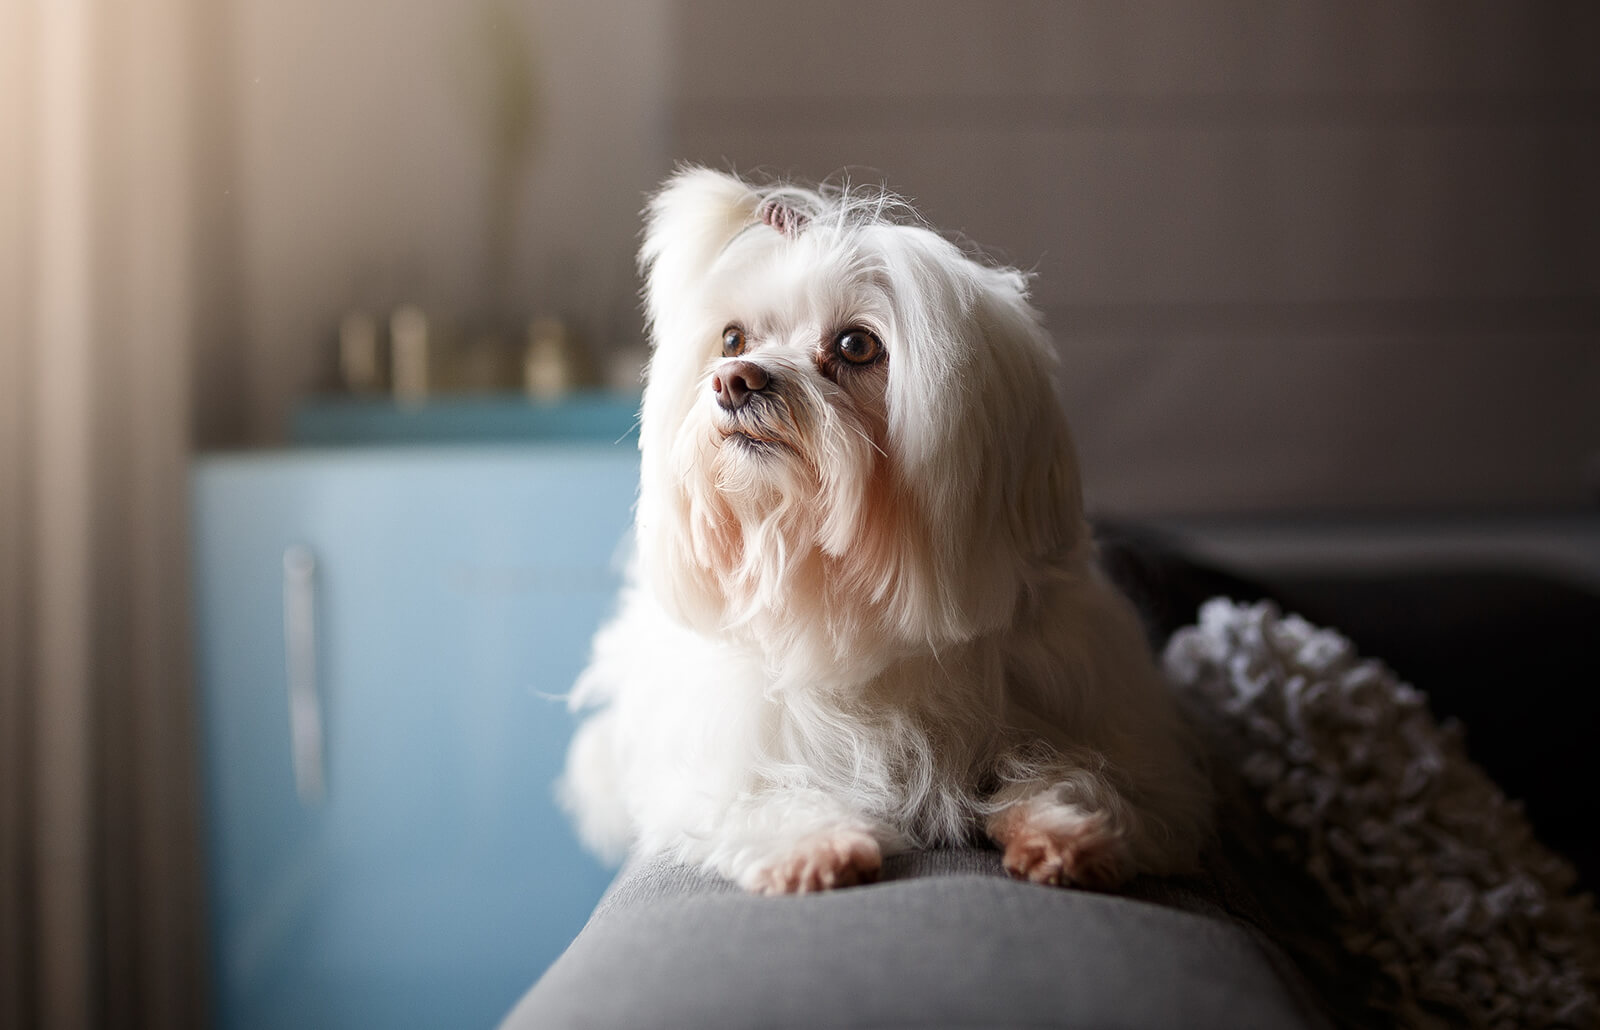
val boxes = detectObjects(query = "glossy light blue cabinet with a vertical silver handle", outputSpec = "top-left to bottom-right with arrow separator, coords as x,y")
192,441 -> 638,1030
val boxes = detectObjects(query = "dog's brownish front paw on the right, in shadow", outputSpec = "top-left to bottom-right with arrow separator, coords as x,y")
989,801 -> 1133,891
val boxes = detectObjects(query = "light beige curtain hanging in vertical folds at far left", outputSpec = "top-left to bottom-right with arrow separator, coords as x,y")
0,0 -> 205,1030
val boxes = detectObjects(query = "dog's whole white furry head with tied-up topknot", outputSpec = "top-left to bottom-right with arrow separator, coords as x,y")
624,170 -> 1085,675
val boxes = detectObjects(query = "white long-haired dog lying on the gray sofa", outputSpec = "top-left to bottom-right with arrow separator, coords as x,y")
562,168 -> 1208,892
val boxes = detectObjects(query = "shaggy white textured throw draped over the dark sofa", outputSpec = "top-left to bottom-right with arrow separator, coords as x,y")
1165,600 -> 1600,1028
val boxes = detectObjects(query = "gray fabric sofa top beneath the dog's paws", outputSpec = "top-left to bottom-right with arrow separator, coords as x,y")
506,848 -> 1325,1030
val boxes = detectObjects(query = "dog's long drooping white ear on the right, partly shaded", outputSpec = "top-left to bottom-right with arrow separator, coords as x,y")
888,227 -> 1083,640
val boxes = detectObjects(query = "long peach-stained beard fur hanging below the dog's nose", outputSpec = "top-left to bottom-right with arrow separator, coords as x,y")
670,350 -> 893,678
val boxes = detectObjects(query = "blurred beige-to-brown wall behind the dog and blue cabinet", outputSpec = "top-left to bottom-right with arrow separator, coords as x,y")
200,0 -> 1600,512
